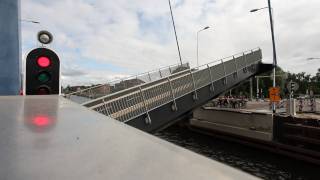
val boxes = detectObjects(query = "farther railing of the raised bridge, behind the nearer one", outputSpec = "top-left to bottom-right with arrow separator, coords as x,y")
64,63 -> 190,103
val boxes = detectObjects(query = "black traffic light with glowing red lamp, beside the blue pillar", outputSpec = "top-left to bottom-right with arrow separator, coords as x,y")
26,47 -> 60,95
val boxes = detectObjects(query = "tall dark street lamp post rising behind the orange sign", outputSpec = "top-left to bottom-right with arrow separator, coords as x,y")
250,0 -> 277,113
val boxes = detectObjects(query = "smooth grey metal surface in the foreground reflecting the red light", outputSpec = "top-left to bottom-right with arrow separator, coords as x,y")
0,96 -> 256,180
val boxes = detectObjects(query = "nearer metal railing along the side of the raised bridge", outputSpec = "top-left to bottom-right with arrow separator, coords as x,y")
83,49 -> 262,123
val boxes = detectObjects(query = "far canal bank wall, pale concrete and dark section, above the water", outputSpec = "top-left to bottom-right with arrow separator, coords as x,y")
188,102 -> 320,165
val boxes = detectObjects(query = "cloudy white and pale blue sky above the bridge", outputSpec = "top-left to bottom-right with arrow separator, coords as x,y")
21,0 -> 320,85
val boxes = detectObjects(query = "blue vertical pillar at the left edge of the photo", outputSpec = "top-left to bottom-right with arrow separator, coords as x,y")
0,0 -> 21,95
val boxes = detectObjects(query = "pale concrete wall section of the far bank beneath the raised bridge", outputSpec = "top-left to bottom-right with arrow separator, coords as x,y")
190,107 -> 273,141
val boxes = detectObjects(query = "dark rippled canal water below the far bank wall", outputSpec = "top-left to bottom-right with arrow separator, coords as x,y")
155,126 -> 320,180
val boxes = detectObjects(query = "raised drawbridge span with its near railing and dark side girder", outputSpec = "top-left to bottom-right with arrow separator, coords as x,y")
83,49 -> 272,132
